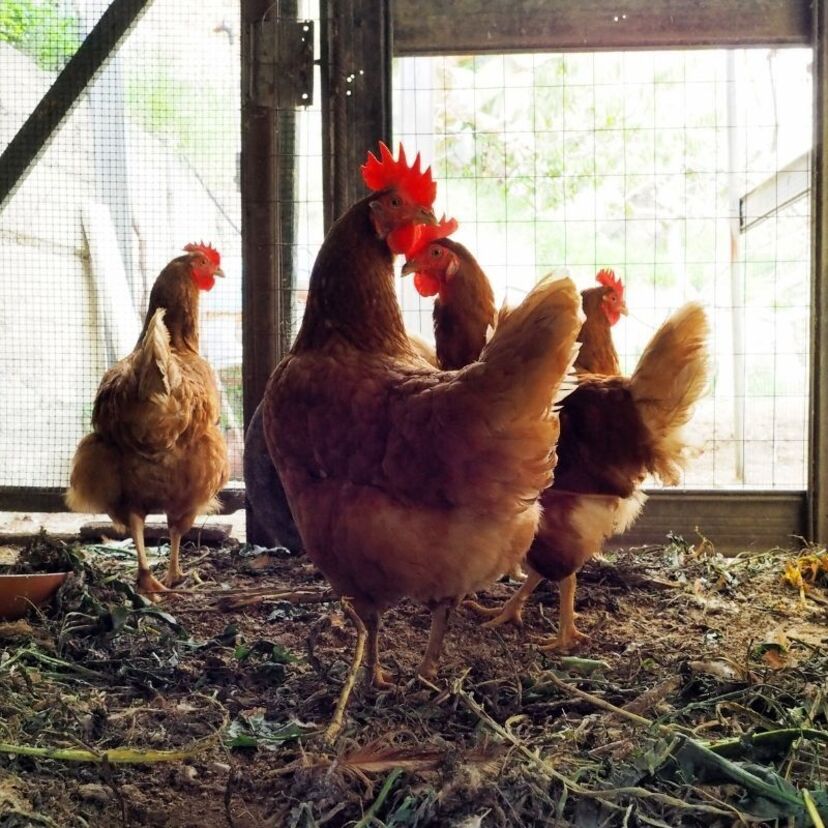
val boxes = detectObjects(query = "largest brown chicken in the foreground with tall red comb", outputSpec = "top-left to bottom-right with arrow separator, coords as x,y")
263,144 -> 579,686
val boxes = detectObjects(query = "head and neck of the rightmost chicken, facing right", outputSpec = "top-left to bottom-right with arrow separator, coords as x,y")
575,270 -> 627,377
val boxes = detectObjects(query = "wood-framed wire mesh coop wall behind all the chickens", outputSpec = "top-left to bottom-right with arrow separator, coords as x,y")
0,0 -> 828,545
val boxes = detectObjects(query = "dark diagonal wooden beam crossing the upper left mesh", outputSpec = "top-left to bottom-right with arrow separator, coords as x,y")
0,0 -> 151,209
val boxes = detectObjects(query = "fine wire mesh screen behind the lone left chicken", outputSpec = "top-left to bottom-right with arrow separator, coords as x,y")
0,0 -> 242,487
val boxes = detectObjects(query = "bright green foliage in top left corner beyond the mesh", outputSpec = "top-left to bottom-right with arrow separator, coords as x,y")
0,0 -> 81,72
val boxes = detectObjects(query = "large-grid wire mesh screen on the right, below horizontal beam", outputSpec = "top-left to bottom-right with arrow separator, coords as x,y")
394,49 -> 812,489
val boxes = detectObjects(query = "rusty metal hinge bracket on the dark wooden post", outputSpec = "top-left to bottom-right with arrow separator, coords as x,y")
250,17 -> 313,109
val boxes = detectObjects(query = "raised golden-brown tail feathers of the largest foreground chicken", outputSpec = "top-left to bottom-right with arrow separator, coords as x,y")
480,277 -> 581,418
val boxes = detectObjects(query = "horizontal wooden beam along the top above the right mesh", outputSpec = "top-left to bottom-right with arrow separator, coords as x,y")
394,0 -> 812,55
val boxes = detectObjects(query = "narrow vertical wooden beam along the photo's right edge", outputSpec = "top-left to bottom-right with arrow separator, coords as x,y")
808,0 -> 828,543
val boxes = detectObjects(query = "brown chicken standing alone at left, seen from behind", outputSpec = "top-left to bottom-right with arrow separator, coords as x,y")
66,244 -> 229,599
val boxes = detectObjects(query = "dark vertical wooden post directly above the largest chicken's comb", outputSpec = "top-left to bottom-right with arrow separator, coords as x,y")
320,0 -> 391,231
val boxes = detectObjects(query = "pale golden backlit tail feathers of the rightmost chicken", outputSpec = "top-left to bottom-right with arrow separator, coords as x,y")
630,302 -> 710,485
